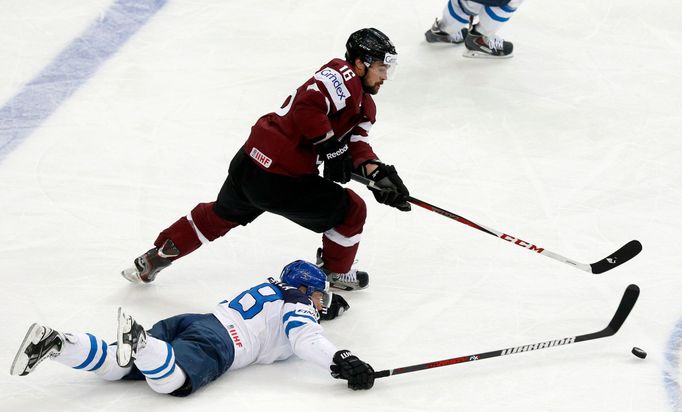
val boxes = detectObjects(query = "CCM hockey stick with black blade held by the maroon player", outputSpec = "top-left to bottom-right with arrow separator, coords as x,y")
352,174 -> 642,274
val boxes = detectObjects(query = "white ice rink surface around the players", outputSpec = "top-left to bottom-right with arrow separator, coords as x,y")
0,0 -> 682,412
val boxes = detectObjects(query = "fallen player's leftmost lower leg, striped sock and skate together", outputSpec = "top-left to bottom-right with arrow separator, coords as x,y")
10,323 -> 130,381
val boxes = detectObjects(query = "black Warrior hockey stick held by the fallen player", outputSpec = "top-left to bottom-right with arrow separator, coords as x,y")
374,284 -> 639,378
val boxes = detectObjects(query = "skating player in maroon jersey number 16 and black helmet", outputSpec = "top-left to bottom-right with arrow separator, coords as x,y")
121,28 -> 410,290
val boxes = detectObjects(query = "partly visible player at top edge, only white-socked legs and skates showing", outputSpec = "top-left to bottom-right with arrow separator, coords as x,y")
424,0 -> 523,58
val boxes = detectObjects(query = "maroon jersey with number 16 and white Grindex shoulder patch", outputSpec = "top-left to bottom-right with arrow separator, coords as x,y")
244,59 -> 378,176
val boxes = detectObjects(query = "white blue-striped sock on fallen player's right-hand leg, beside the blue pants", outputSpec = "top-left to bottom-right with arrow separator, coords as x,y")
135,335 -> 187,393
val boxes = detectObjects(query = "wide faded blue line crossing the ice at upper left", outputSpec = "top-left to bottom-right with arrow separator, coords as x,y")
0,0 -> 167,161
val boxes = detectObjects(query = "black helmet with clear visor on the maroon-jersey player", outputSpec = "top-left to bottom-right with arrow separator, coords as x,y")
346,28 -> 398,67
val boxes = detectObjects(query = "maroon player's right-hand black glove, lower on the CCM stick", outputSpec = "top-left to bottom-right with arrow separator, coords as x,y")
360,160 -> 412,212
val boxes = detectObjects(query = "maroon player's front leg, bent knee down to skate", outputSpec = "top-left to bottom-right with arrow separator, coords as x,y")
317,189 -> 369,290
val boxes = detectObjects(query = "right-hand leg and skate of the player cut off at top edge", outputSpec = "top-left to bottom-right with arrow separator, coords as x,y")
462,0 -> 523,58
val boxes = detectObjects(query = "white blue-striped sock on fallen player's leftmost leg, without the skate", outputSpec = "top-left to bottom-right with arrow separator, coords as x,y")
54,333 -> 131,381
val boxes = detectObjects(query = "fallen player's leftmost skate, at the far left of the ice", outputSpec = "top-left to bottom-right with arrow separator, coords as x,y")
9,323 -> 64,376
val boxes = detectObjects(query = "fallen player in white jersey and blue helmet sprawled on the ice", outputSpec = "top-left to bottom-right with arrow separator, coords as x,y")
10,260 -> 374,396
